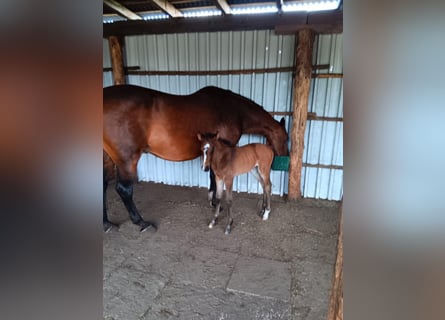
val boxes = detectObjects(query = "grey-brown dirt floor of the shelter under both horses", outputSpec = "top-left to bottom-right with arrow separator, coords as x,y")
103,183 -> 339,320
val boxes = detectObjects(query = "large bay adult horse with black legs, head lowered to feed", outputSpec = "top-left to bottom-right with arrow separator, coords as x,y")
103,85 -> 288,231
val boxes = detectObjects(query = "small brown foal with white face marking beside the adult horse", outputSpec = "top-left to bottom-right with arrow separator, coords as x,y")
198,133 -> 274,234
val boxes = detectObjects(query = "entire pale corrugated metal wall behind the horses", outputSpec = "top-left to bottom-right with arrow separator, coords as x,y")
104,30 -> 343,200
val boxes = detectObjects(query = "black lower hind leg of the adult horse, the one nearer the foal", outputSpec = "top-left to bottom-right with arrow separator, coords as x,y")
116,166 -> 157,232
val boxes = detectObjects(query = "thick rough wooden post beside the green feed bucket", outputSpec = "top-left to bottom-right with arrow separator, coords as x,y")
288,29 -> 315,200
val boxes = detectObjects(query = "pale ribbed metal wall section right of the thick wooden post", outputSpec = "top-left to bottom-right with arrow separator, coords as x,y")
301,34 -> 343,200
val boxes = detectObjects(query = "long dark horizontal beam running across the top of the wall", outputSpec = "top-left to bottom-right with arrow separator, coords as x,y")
103,11 -> 343,37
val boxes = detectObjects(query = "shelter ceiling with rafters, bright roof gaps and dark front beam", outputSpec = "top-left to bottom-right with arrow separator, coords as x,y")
103,0 -> 343,37
